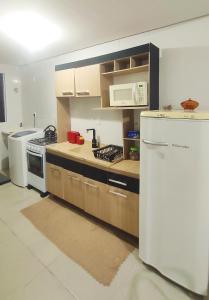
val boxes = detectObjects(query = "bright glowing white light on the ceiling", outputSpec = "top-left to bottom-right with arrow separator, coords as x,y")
0,12 -> 61,51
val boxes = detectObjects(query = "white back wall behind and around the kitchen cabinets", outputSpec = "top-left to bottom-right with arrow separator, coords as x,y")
22,17 -> 209,144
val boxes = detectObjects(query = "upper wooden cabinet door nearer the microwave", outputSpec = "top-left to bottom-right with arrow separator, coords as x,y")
75,65 -> 101,97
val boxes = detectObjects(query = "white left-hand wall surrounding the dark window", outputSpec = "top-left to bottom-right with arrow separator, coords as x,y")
0,65 -> 22,170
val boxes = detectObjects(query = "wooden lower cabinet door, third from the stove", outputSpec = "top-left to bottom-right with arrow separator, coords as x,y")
83,177 -> 104,218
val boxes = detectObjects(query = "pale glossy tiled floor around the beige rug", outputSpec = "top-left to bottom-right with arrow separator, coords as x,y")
0,183 -> 206,300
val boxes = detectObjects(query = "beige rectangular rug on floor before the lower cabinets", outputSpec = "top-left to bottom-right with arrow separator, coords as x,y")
22,198 -> 134,285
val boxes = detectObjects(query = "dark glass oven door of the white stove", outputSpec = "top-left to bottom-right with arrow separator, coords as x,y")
27,150 -> 44,178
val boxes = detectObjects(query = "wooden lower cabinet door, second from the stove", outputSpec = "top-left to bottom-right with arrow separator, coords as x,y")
64,170 -> 84,209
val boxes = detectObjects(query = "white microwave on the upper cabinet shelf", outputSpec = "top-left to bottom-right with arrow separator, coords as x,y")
109,81 -> 148,106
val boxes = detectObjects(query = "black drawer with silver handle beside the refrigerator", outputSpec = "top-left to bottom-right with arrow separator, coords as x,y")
107,172 -> 139,194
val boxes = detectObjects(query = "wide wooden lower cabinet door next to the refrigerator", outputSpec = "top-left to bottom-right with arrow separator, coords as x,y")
102,186 -> 139,236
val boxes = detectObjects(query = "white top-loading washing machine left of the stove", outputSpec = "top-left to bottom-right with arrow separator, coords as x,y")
8,128 -> 44,187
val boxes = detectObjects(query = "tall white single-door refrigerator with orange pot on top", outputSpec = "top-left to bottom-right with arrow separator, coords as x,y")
139,111 -> 209,295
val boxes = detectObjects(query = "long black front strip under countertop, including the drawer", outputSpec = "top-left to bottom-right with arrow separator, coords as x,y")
46,152 -> 139,194
